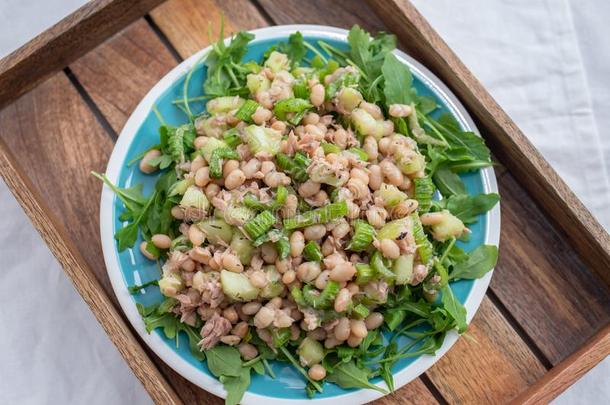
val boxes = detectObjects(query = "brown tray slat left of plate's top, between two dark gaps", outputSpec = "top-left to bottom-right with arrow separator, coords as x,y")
70,19 -> 176,133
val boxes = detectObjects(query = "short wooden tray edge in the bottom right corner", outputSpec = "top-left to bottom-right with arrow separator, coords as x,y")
512,324 -> 610,405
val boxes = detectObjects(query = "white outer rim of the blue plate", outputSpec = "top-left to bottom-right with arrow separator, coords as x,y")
100,24 -> 500,405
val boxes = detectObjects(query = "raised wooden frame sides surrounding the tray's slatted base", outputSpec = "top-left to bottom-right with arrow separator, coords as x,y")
0,0 -> 610,404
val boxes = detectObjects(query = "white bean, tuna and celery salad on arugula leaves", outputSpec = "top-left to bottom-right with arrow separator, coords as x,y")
93,26 -> 499,404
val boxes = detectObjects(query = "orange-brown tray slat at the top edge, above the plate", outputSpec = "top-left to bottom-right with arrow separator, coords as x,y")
150,0 -> 267,59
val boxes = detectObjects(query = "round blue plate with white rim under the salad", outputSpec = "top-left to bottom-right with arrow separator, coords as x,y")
101,26 -> 499,403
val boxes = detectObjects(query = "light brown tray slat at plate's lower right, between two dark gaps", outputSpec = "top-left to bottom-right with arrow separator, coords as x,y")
427,298 -> 546,404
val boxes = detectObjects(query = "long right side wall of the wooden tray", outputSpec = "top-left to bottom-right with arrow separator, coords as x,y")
368,0 -> 610,285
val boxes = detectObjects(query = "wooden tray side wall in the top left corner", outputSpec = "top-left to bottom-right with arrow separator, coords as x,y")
0,0 -> 162,108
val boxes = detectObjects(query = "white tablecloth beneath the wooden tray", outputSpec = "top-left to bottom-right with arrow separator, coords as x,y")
0,0 -> 610,404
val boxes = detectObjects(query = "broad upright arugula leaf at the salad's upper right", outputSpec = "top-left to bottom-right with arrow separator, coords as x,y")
381,53 -> 414,106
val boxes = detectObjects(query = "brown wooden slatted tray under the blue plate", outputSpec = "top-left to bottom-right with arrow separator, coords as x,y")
0,0 -> 610,404
